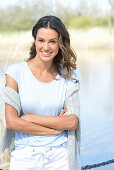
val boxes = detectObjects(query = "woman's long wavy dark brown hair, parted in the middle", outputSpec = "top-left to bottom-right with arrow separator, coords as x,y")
27,15 -> 77,80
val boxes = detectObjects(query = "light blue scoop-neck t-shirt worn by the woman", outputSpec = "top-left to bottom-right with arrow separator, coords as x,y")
5,62 -> 76,149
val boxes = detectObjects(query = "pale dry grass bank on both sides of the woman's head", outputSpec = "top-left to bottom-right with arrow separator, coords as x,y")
0,28 -> 114,63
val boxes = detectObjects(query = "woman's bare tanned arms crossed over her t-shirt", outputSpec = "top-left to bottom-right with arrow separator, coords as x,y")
5,75 -> 78,135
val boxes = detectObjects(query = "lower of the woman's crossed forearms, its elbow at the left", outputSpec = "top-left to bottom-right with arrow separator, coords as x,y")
5,104 -> 61,135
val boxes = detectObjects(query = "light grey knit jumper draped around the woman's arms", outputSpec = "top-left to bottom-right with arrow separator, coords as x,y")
0,83 -> 81,170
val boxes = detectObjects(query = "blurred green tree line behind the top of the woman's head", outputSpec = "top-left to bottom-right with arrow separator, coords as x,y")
0,0 -> 114,31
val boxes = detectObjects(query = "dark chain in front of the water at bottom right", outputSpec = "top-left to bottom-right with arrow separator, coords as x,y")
81,159 -> 114,170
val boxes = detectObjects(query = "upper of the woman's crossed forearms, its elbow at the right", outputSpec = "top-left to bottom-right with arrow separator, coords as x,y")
22,114 -> 78,130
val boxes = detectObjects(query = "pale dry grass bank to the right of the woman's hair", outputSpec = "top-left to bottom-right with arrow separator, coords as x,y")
70,28 -> 114,50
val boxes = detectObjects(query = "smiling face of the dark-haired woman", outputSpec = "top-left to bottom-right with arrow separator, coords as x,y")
35,28 -> 59,62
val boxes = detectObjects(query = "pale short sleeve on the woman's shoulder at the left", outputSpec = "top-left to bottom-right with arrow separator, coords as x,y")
5,64 -> 18,83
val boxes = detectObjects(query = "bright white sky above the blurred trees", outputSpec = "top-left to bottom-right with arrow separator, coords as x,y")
0,0 -> 114,13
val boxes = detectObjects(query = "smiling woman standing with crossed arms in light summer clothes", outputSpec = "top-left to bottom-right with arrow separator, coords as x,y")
1,16 -> 80,170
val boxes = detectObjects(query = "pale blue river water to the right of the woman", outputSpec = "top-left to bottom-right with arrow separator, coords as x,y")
0,48 -> 114,170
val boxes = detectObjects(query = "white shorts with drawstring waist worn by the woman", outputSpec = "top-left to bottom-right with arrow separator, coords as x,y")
9,146 -> 68,170
